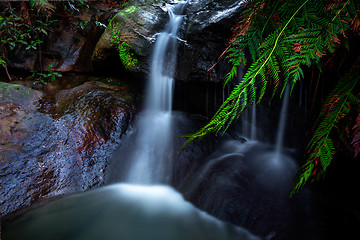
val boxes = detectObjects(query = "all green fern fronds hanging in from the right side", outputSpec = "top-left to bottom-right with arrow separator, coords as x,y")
186,0 -> 360,193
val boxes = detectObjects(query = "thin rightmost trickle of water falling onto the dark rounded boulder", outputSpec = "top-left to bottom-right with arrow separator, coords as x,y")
275,85 -> 290,159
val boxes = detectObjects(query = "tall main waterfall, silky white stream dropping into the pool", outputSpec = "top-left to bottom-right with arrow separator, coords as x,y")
126,2 -> 187,184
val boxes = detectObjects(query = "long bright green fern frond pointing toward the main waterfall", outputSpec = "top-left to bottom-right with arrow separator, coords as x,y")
184,0 -> 309,145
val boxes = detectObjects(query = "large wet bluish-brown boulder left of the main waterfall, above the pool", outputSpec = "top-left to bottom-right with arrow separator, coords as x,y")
0,82 -> 134,218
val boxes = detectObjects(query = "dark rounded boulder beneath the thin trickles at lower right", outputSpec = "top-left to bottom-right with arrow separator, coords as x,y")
179,140 -> 318,240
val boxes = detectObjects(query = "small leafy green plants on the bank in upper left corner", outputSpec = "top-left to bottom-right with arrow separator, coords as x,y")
0,0 -> 127,83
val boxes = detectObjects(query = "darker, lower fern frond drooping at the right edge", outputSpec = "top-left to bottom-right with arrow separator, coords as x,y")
292,59 -> 360,194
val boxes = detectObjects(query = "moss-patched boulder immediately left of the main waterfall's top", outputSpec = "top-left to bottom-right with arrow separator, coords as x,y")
92,1 -> 171,73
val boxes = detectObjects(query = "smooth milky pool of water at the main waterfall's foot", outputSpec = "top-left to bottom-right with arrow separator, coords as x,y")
2,184 -> 259,240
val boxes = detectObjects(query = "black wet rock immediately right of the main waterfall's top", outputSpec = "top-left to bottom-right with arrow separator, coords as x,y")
176,0 -> 243,82
